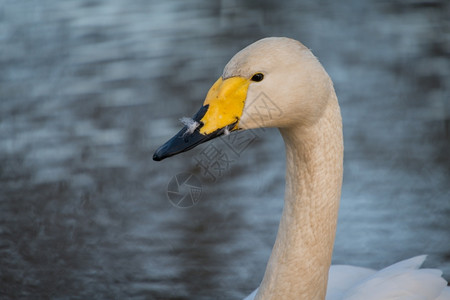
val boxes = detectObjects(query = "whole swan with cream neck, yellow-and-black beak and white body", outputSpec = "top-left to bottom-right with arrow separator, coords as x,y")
153,37 -> 450,300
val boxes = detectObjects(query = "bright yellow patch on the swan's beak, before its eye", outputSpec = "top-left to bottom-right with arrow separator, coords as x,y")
200,77 -> 250,135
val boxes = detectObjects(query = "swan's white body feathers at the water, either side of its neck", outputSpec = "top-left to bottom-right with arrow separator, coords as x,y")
244,255 -> 450,300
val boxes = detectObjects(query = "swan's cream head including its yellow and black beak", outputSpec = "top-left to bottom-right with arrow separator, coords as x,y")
153,37 -> 333,160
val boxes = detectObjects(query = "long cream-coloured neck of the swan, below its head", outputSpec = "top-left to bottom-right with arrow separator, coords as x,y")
255,95 -> 343,300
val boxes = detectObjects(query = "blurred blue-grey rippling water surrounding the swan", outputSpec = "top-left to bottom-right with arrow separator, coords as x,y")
0,0 -> 450,299
